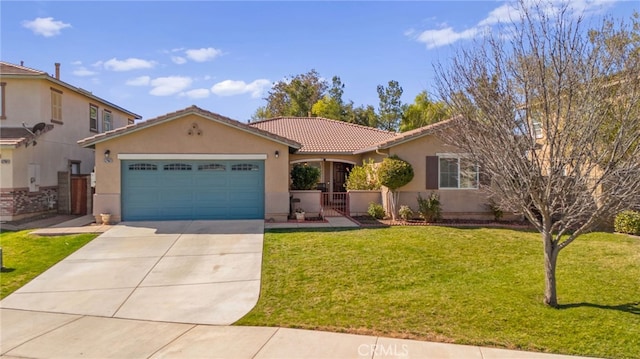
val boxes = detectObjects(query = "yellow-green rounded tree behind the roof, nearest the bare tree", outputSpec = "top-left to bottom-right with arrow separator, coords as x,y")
400,91 -> 451,132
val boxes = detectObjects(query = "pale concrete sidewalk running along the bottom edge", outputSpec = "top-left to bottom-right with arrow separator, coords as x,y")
0,309 -> 592,359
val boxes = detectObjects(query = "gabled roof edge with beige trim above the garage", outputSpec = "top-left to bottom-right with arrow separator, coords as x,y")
78,106 -> 302,149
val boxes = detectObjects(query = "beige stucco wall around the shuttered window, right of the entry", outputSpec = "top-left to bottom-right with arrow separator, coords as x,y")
380,131 -> 491,219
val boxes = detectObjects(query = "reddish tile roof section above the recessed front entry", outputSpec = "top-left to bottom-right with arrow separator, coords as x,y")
249,117 -> 396,154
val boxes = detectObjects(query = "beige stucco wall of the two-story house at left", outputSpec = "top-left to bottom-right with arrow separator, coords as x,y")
1,78 -> 129,189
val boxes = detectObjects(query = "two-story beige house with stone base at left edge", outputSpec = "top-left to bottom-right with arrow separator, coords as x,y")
0,62 -> 140,221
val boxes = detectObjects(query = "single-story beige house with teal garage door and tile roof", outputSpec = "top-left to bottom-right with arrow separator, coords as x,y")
78,106 -> 491,221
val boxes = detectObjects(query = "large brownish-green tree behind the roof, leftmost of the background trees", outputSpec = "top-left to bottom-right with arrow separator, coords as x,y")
251,70 -> 328,120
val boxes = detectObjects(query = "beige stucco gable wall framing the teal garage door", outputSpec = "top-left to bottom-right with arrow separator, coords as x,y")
93,114 -> 289,221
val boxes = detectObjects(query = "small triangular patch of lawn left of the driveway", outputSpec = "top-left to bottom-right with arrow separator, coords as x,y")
0,230 -> 97,298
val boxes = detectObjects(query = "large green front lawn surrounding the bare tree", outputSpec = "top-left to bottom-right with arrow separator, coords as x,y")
237,226 -> 640,358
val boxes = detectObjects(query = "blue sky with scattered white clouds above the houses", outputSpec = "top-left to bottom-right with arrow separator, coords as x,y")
0,0 -> 640,122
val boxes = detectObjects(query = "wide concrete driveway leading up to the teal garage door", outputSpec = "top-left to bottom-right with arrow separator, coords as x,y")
0,220 -> 264,325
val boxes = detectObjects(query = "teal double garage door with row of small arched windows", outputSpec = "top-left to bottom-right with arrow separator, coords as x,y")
122,160 -> 264,221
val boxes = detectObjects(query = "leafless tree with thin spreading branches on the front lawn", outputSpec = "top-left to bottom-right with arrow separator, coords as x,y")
436,1 -> 640,307
